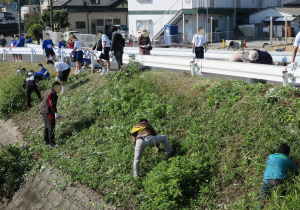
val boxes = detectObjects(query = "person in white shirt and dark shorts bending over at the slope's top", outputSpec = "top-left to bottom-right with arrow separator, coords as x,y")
47,60 -> 71,94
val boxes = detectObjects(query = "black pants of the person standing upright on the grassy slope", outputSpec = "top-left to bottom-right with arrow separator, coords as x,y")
43,113 -> 55,144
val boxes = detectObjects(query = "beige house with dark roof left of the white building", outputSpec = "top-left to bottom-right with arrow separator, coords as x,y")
41,0 -> 128,34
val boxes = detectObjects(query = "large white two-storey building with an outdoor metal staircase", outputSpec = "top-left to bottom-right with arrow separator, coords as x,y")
128,0 -> 293,42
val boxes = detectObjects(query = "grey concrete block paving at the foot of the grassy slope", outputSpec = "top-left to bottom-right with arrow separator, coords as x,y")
0,120 -> 117,210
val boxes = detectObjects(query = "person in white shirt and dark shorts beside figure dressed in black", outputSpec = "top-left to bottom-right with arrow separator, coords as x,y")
98,31 -> 110,75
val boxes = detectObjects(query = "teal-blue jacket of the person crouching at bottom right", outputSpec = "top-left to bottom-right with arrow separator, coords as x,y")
264,153 -> 299,179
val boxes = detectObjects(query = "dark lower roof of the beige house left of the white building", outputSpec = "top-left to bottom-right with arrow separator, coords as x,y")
65,6 -> 128,12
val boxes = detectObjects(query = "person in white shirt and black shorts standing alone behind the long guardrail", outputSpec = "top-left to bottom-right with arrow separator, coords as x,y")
192,27 -> 208,59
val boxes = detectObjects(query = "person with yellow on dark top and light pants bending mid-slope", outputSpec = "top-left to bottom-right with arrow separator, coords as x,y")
131,119 -> 174,177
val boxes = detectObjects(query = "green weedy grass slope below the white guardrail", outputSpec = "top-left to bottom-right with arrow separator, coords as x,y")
2,61 -> 300,209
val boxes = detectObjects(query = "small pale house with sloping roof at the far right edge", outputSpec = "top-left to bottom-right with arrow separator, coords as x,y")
249,7 -> 300,37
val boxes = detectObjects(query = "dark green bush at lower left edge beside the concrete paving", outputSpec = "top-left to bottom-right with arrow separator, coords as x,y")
0,145 -> 33,196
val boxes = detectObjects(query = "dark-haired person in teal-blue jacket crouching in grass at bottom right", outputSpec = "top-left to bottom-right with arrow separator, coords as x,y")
259,144 -> 299,205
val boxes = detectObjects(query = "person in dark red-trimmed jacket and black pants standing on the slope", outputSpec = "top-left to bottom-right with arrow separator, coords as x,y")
40,82 -> 61,147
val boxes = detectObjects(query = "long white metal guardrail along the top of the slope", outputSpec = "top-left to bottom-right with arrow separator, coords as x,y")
0,44 -> 300,85
